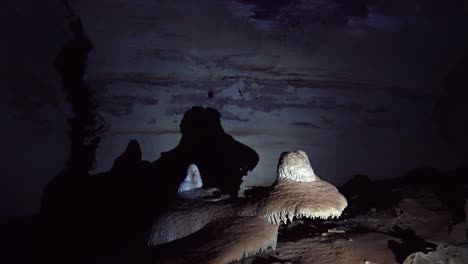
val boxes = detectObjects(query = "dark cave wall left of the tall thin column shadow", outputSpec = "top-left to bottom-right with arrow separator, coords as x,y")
0,0 -> 69,221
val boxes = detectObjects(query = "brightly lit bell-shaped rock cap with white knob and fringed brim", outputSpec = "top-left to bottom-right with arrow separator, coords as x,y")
257,150 -> 348,224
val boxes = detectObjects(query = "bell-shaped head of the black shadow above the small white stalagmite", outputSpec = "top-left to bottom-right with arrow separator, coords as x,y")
153,107 -> 259,197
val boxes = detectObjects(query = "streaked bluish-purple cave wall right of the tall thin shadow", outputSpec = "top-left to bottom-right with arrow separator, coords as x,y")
76,0 -> 466,188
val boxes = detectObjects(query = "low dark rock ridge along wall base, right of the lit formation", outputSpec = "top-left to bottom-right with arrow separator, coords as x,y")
339,165 -> 468,222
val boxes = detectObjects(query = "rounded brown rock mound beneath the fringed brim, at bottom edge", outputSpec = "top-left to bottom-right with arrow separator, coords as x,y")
155,217 -> 278,264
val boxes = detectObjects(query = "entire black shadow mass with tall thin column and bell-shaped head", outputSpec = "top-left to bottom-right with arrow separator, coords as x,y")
33,1 -> 259,263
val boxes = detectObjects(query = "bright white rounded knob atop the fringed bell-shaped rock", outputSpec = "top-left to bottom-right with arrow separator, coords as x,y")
278,150 -> 317,182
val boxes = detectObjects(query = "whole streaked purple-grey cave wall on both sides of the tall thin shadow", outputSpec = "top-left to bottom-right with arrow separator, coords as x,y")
0,0 -> 468,222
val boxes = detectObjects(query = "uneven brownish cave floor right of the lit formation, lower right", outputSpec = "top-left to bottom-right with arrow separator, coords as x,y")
236,188 -> 468,264
